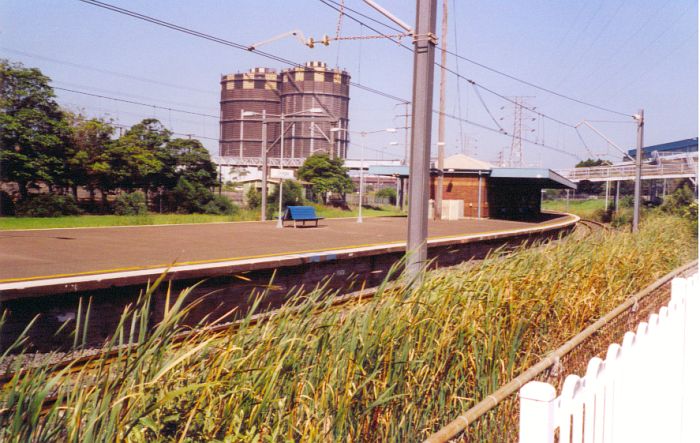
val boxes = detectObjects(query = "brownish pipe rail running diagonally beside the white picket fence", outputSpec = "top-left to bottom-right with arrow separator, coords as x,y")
424,259 -> 698,443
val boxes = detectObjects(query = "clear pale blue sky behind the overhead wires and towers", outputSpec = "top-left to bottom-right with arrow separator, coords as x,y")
0,0 -> 698,168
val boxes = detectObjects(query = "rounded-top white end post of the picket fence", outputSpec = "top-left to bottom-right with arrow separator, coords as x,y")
520,381 -> 557,443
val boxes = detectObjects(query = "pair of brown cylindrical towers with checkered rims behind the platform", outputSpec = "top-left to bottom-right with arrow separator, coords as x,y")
219,62 -> 350,167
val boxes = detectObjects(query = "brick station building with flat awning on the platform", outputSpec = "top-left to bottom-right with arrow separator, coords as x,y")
369,154 -> 576,220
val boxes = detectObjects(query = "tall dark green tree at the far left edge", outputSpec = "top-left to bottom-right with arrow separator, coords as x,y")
0,59 -> 69,199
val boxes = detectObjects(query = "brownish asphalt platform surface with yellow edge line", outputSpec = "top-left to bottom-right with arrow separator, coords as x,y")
0,216 -> 572,283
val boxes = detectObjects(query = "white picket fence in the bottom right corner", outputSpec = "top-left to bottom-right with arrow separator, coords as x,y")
520,274 -> 700,443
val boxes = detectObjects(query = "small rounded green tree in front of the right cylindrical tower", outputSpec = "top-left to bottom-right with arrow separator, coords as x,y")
297,153 -> 353,203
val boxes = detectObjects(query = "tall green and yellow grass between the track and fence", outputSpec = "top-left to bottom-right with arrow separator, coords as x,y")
0,216 -> 697,442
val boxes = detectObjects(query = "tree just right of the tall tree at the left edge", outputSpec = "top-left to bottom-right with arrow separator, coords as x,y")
66,113 -> 115,202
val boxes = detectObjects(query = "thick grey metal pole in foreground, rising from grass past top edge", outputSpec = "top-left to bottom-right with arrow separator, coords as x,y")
406,0 -> 437,278
